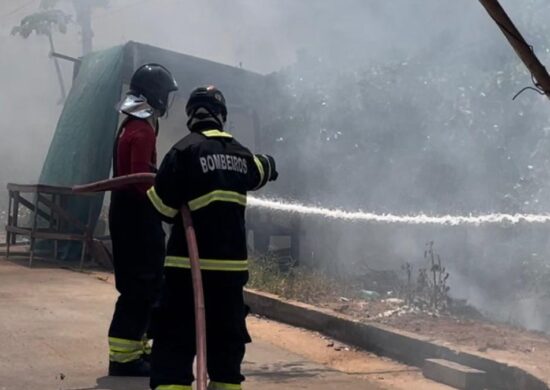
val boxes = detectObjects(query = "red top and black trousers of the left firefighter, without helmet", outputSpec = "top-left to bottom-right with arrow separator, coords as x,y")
109,117 -> 165,363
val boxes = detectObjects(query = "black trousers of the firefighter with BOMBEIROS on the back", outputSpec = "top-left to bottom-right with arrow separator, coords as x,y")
151,267 -> 251,389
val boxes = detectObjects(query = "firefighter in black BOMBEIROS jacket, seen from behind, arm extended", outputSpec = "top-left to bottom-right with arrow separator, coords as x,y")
147,86 -> 278,390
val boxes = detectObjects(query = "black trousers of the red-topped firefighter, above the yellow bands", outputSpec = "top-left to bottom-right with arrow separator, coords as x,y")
109,191 -> 165,340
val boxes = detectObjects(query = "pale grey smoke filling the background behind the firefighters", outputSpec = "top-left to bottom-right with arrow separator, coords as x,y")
0,0 -> 550,330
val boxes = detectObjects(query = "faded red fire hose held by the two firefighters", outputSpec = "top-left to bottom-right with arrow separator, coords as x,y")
73,173 -> 207,390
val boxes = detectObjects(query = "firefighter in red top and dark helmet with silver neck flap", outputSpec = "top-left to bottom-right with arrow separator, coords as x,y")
109,64 -> 178,376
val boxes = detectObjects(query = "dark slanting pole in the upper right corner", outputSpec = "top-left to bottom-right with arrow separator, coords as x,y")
479,0 -> 550,98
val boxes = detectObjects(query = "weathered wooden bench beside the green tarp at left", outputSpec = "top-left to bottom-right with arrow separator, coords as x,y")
6,183 -> 94,268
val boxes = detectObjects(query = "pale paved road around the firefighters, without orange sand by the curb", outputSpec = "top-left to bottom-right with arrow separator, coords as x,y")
0,260 -> 389,390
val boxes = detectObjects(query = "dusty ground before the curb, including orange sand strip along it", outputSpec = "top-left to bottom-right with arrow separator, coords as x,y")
0,258 -> 448,390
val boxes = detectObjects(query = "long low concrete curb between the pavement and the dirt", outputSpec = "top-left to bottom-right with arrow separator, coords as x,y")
245,289 -> 550,390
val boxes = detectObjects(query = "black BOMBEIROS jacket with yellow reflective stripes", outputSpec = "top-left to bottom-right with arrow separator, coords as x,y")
147,130 -> 275,273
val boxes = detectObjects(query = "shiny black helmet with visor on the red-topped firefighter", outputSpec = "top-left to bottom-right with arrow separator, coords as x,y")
130,64 -> 178,115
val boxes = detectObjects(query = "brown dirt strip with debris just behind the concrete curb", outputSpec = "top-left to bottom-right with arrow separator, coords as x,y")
319,298 -> 550,383
